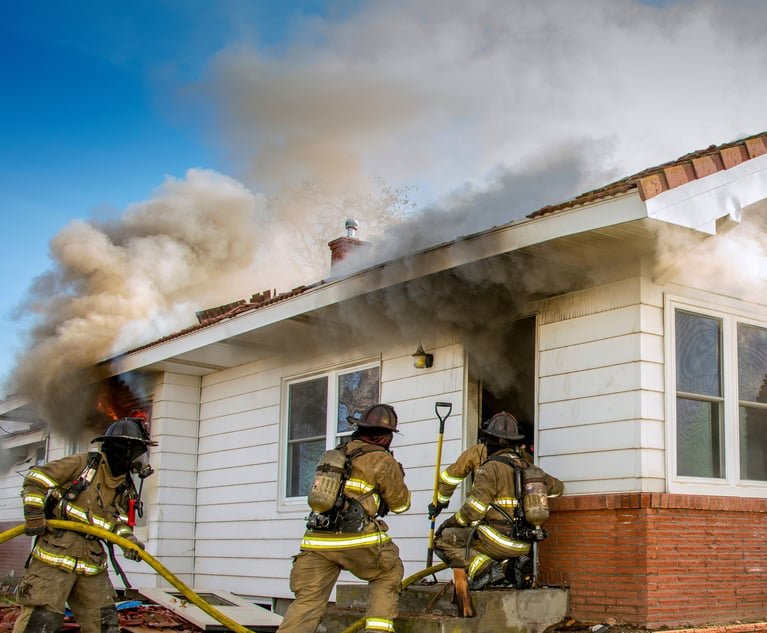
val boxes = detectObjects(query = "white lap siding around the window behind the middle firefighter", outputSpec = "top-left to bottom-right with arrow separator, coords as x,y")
195,341 -> 464,598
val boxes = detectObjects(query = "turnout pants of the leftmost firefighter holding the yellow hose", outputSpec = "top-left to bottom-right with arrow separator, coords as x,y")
13,558 -> 118,633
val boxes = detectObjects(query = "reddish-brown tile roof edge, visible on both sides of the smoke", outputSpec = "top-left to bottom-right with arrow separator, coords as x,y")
114,131 -> 767,354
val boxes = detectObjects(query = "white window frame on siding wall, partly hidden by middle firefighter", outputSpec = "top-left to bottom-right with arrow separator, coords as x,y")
277,357 -> 383,512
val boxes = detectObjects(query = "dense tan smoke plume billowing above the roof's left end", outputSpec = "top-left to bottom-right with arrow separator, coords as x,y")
6,170 -> 263,431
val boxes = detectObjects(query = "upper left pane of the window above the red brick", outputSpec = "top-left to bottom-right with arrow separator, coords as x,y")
676,310 -> 722,396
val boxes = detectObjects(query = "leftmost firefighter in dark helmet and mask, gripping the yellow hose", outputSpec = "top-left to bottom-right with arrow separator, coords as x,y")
13,418 -> 157,633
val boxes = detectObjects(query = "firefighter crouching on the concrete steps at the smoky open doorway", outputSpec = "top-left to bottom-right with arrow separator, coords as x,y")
429,411 -> 563,589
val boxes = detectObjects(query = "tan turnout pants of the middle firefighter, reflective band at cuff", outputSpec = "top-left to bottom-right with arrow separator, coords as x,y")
277,541 -> 405,633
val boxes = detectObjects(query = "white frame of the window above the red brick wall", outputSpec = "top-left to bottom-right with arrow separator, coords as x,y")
664,295 -> 767,497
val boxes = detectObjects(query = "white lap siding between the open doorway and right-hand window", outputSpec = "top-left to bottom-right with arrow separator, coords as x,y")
536,277 -> 665,494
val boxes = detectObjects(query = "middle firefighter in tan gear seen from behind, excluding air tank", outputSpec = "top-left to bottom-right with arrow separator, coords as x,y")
277,404 -> 410,633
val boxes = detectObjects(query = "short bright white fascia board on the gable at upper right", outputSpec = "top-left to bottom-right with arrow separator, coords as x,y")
646,154 -> 767,235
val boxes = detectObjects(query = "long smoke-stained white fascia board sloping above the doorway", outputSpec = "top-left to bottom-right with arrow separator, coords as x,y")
111,192 -> 647,373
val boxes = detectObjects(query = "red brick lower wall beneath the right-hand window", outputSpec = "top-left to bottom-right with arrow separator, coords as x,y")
539,493 -> 767,627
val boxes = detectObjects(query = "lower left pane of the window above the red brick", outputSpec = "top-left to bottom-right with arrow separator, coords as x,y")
676,398 -> 724,478
